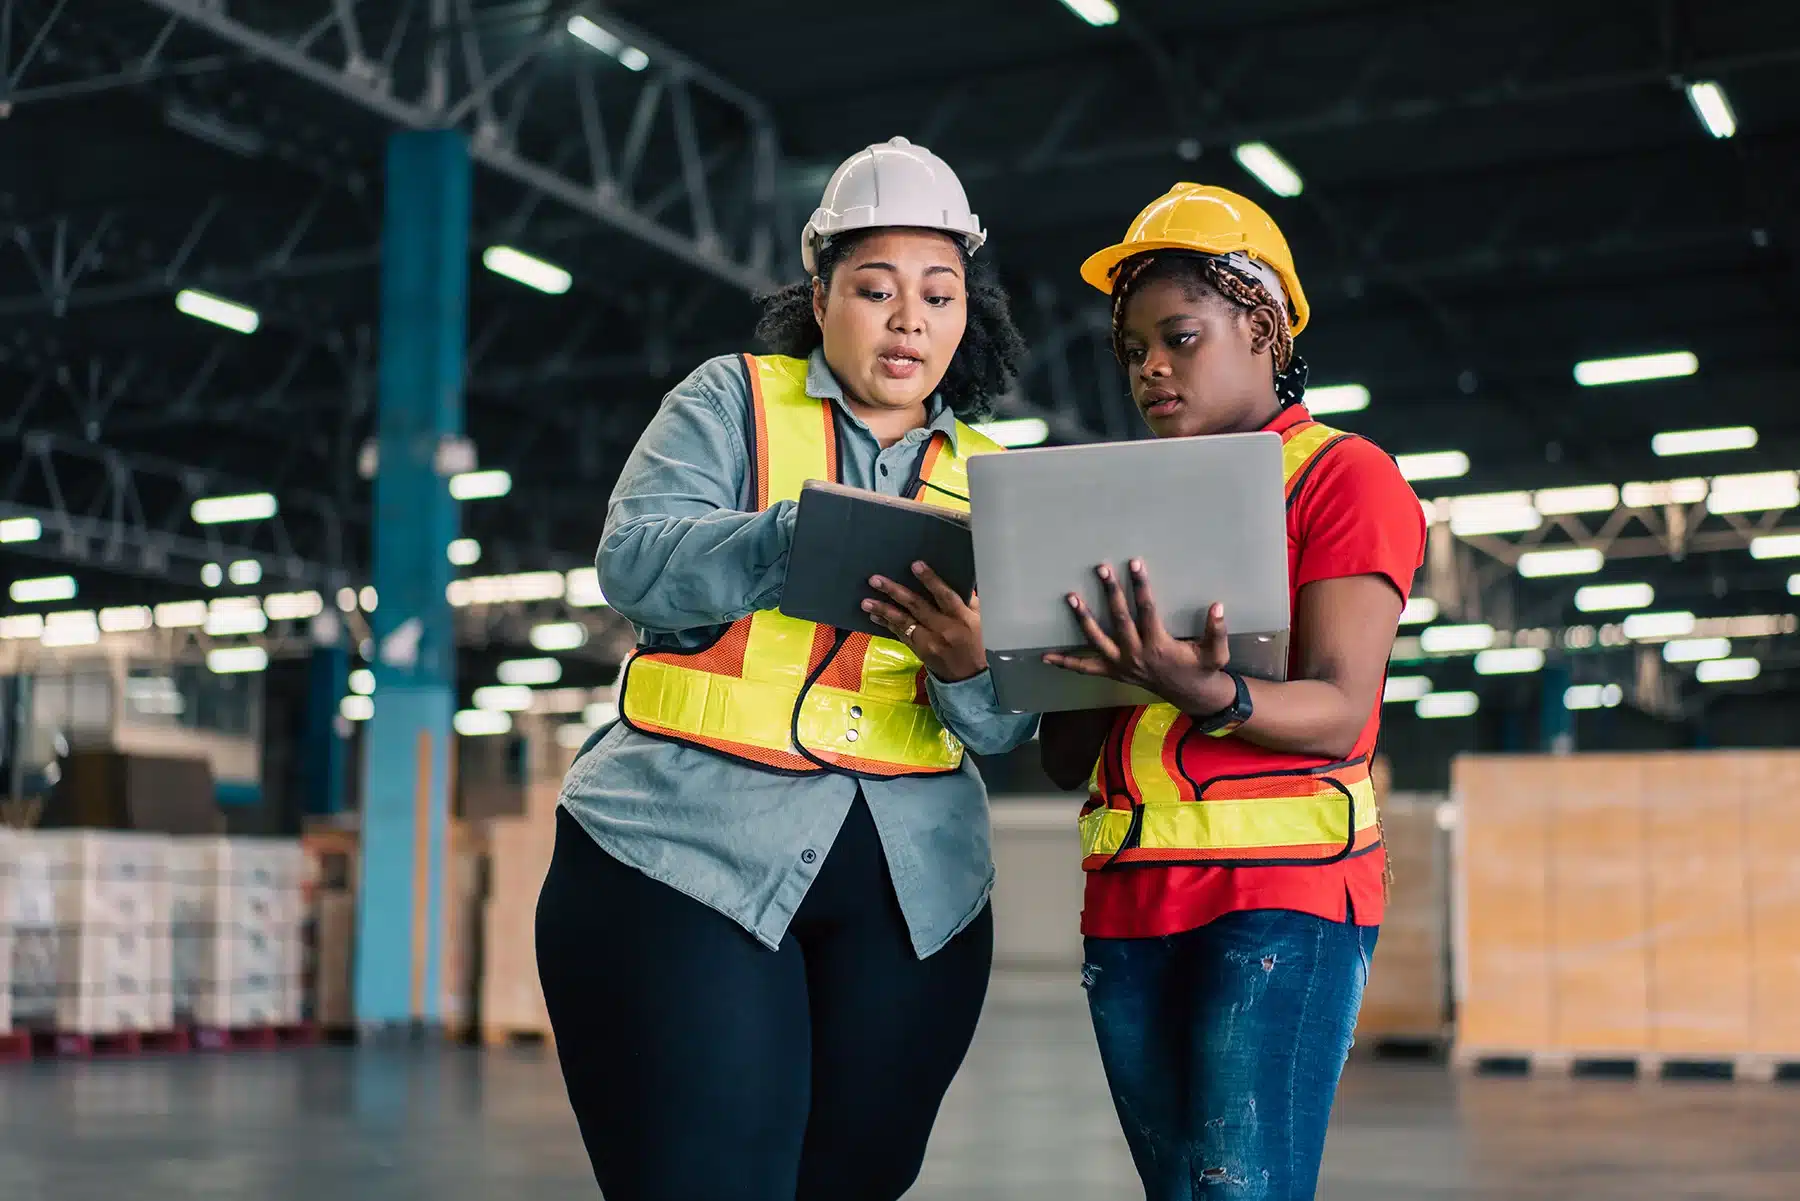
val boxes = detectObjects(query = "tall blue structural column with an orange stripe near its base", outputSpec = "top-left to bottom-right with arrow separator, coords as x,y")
355,130 -> 470,1026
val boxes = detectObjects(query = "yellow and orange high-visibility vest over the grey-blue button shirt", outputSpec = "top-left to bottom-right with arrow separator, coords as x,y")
619,355 -> 1001,778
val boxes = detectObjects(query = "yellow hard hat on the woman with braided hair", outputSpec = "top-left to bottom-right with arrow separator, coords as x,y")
1082,184 -> 1312,333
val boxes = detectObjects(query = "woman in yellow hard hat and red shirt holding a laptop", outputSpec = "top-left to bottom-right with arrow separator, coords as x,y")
1040,184 -> 1426,1201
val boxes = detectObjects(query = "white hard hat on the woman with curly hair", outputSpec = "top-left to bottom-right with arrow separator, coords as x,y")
799,137 -> 988,272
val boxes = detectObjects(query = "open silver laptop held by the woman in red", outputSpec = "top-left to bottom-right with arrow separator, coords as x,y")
968,432 -> 1289,713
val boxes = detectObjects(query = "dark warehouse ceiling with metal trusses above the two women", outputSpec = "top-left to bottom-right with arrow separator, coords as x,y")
0,0 -> 1800,698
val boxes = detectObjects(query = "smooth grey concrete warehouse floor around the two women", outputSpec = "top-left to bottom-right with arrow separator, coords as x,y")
0,976 -> 1800,1201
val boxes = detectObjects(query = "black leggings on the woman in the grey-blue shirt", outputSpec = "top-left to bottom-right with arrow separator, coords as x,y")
538,798 -> 994,1201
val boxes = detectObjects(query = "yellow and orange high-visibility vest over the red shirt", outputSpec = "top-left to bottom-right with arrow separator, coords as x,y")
1080,421 -> 1381,871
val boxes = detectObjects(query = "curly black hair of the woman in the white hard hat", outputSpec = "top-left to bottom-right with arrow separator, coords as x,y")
756,230 -> 1026,421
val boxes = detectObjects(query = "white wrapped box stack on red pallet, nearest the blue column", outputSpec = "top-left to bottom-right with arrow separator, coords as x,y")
169,837 -> 304,1030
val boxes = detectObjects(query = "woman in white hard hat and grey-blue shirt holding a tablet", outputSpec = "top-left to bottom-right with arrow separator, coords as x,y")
536,139 -> 1037,1201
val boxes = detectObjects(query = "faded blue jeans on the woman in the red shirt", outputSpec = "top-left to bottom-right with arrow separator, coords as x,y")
1082,909 -> 1379,1201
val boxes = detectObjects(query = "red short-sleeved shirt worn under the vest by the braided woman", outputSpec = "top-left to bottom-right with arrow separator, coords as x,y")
1082,405 -> 1426,938
